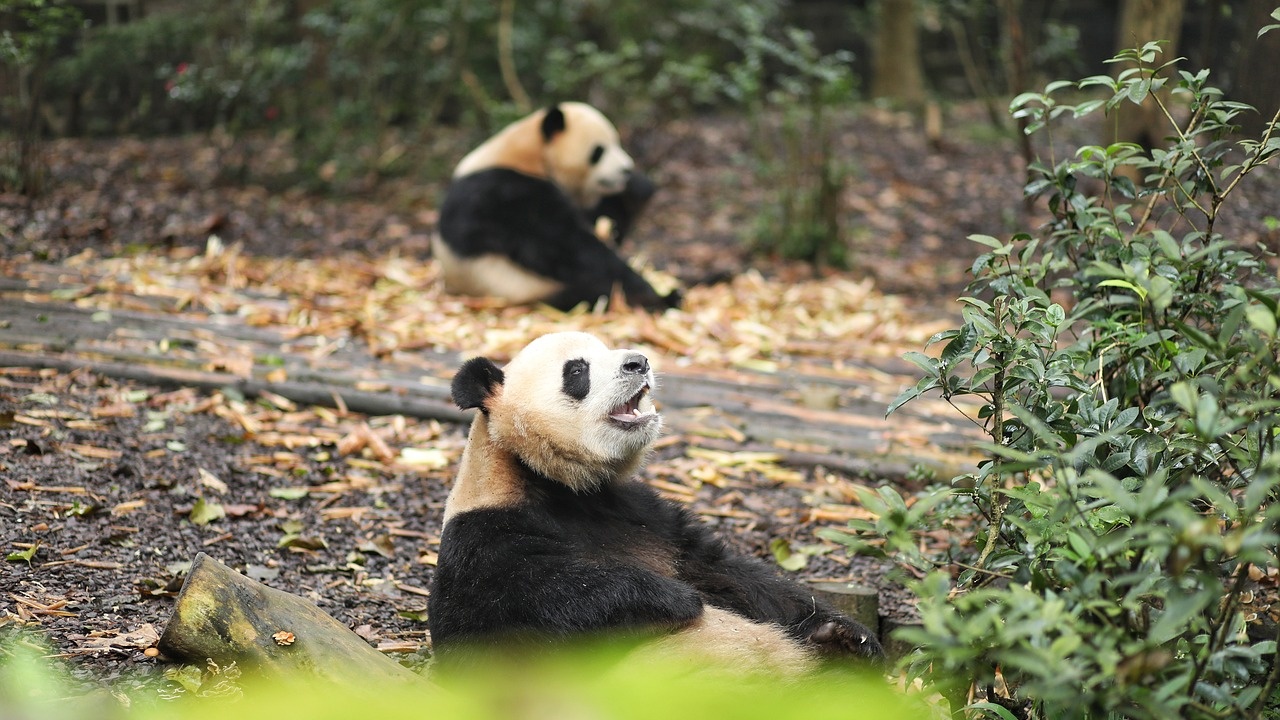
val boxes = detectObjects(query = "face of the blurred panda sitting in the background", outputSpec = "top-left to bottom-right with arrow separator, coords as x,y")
545,102 -> 635,209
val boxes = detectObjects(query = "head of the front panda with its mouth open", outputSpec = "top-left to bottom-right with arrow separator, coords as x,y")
452,332 -> 662,492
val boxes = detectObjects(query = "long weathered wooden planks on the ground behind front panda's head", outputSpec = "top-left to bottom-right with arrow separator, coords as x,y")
0,296 -> 978,477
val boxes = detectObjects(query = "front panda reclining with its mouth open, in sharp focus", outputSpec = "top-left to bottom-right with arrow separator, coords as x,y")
428,332 -> 882,678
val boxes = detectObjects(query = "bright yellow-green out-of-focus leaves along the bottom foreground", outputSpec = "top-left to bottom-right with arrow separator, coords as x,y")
0,632 -> 941,720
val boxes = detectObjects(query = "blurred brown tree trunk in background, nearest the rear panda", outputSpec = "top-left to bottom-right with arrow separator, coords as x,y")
872,0 -> 924,110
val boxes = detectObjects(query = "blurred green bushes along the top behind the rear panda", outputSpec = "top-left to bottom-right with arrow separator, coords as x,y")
37,0 -> 819,170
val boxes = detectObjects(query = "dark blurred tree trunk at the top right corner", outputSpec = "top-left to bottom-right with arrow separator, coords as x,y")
1231,0 -> 1280,140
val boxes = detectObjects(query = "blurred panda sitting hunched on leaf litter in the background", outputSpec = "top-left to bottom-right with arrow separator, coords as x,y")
433,102 -> 680,310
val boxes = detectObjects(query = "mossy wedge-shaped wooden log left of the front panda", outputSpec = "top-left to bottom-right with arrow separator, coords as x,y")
159,552 -> 425,685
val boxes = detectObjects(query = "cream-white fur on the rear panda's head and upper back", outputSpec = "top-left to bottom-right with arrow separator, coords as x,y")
453,102 -> 635,210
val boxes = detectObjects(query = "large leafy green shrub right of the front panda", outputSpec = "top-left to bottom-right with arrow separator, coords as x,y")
833,32 -> 1280,719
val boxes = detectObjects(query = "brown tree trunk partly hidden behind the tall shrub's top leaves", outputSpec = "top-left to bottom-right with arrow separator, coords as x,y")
1105,0 -> 1185,150
